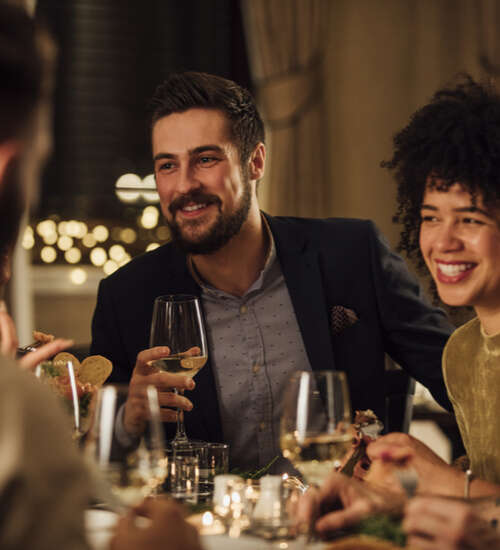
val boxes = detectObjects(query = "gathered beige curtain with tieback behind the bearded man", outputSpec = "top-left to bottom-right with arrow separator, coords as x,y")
241,0 -> 330,217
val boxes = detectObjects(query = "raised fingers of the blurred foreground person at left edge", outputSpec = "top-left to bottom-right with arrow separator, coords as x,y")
0,300 -> 74,371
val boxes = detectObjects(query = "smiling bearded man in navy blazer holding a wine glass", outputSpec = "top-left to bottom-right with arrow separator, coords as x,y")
92,72 -> 451,469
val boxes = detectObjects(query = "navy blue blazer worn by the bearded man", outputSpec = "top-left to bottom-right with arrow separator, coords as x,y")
91,215 -> 453,441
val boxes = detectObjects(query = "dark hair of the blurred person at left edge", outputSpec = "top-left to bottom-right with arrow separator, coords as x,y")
0,3 -> 44,142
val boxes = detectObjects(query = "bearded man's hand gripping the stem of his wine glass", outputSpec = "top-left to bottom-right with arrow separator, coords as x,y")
124,352 -> 195,435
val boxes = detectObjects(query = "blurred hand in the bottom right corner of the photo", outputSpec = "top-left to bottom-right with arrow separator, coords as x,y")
403,497 -> 500,550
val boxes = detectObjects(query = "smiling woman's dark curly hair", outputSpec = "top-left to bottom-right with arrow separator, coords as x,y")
381,75 -> 500,268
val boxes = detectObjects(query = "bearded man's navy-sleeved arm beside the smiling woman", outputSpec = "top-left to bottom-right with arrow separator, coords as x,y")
369,225 -> 454,410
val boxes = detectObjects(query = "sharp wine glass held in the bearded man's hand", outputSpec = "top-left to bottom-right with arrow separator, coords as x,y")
149,294 -> 207,446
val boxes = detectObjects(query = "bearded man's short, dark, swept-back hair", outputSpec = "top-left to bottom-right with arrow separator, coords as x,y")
151,72 -> 265,163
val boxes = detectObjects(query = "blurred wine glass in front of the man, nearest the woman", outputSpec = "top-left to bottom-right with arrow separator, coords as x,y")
280,371 -> 353,485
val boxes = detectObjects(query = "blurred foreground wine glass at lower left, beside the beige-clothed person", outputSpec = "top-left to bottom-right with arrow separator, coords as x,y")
85,384 -> 167,509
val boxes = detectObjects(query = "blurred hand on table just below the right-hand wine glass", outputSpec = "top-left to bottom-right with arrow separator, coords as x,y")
298,473 -> 405,537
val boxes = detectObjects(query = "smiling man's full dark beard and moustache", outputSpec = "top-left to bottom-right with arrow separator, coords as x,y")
167,174 -> 252,254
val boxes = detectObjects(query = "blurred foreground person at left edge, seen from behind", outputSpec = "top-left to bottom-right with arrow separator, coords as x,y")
0,3 -> 200,550
